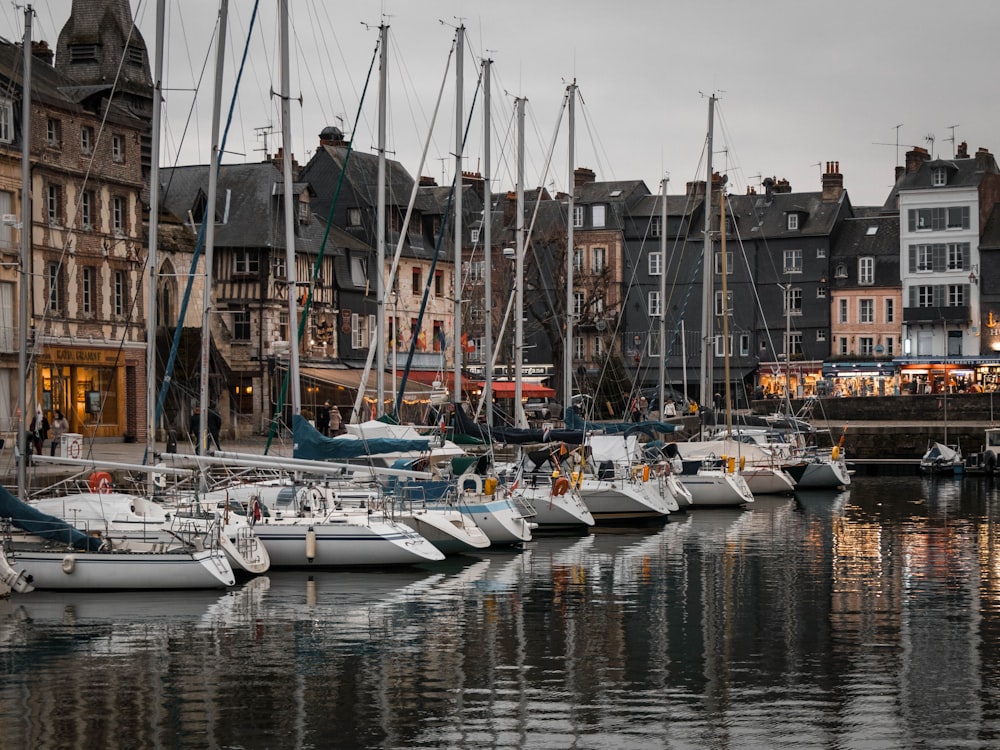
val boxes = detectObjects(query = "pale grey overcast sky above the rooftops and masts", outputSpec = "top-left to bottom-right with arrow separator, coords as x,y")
7,0 -> 1000,206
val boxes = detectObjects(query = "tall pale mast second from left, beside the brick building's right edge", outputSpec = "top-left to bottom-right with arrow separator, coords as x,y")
146,0 -> 166,470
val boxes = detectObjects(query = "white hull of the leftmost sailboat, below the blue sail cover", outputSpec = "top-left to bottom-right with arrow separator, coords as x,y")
14,542 -> 236,591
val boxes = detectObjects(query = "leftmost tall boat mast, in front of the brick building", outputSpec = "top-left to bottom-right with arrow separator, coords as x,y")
17,5 -> 35,499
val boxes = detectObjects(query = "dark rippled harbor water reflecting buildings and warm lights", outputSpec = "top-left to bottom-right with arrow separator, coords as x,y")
0,476 -> 1000,750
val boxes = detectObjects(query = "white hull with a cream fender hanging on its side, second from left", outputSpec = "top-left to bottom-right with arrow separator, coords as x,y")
254,512 -> 444,568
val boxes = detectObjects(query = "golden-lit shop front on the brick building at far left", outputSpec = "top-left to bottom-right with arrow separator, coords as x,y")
36,346 -> 145,439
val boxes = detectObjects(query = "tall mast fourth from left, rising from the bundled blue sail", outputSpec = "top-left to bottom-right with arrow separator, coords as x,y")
278,0 -> 302,417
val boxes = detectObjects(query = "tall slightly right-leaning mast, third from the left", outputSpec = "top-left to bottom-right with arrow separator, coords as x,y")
198,0 -> 229,462
